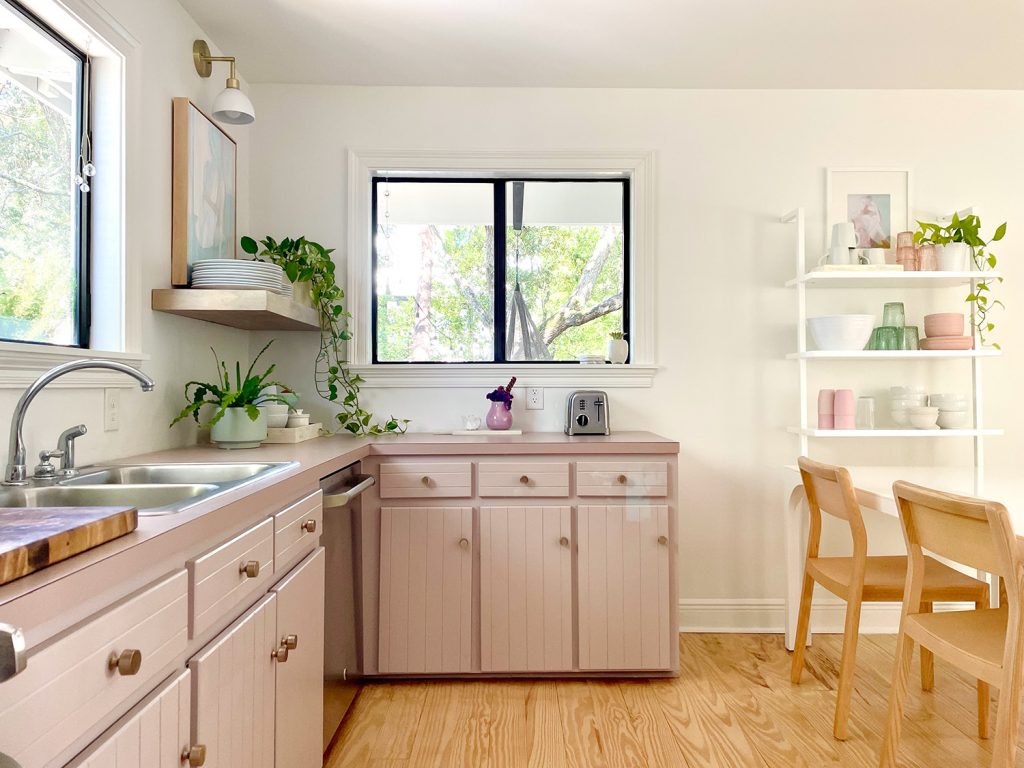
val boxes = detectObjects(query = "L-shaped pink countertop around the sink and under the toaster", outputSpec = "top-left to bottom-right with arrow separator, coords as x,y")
0,432 -> 679,642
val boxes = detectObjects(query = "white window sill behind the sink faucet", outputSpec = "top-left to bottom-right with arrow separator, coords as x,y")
0,341 -> 150,389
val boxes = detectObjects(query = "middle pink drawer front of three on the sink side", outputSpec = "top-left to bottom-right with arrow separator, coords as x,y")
187,519 -> 274,637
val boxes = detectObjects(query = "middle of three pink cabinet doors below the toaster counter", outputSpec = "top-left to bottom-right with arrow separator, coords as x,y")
480,507 -> 572,672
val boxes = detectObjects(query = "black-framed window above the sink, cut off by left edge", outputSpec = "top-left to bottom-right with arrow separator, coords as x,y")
0,0 -> 93,347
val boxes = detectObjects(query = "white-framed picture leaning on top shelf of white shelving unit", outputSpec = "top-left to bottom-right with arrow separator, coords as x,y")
825,168 -> 911,254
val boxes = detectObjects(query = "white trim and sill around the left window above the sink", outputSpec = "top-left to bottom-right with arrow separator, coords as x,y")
0,0 -> 150,389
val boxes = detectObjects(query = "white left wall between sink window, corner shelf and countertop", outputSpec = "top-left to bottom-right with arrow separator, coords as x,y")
0,0 -> 249,469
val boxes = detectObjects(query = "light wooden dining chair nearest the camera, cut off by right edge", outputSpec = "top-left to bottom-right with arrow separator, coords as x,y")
880,480 -> 1024,768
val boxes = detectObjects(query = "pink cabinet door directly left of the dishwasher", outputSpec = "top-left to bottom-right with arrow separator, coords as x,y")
273,548 -> 325,768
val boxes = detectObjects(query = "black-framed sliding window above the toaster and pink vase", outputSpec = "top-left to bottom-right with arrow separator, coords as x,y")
371,176 -> 630,364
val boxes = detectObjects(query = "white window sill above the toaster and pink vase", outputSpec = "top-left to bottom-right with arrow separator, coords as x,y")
349,362 -> 658,389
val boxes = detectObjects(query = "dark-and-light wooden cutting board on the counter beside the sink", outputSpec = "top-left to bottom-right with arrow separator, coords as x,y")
0,507 -> 138,584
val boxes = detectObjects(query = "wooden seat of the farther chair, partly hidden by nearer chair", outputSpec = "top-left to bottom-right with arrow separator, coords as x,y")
807,555 -> 988,602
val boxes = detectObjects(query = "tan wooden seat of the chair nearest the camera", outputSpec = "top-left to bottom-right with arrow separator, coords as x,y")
904,607 -> 1008,686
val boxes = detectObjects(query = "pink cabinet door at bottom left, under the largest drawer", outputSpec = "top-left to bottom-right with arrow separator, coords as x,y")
68,671 -> 191,768
